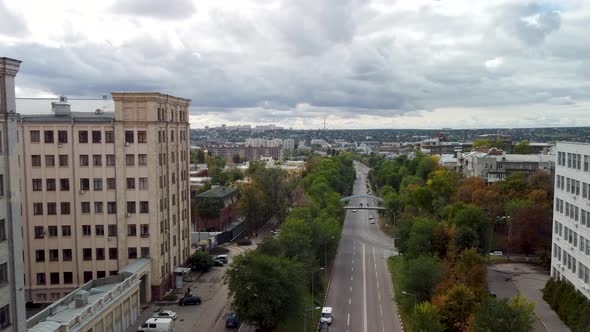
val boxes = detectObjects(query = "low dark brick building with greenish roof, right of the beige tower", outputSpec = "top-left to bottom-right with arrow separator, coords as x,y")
192,186 -> 240,232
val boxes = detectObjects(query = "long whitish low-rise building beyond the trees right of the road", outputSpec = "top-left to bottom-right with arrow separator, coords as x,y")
462,149 -> 555,183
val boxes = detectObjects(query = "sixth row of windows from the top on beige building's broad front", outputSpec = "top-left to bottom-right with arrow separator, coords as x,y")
35,247 -> 150,263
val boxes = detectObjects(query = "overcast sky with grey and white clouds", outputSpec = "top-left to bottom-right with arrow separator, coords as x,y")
0,0 -> 590,128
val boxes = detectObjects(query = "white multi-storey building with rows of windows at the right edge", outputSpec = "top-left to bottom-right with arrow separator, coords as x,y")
551,142 -> 590,299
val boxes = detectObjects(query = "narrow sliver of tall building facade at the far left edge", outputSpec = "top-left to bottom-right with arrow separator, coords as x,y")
0,58 -> 25,332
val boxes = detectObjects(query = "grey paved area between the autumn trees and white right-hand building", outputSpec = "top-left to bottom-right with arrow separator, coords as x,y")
488,263 -> 570,332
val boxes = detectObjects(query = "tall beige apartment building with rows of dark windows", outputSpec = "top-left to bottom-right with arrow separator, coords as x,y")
19,93 -> 190,303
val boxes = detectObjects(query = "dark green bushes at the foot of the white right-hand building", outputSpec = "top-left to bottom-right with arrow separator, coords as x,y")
543,278 -> 590,332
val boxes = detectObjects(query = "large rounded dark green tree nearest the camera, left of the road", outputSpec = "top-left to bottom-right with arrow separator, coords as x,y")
224,250 -> 306,331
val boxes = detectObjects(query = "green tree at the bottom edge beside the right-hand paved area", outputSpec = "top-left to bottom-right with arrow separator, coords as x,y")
473,296 -> 535,332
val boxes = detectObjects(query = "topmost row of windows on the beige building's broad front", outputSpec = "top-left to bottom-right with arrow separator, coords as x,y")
29,130 -> 147,144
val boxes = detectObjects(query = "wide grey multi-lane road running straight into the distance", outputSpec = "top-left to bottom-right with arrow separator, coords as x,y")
325,162 -> 402,332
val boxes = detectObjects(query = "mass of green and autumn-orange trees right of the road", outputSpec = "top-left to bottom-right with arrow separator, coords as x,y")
369,154 -> 552,331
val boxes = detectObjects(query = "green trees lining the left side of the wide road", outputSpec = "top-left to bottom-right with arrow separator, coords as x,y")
225,155 -> 355,330
